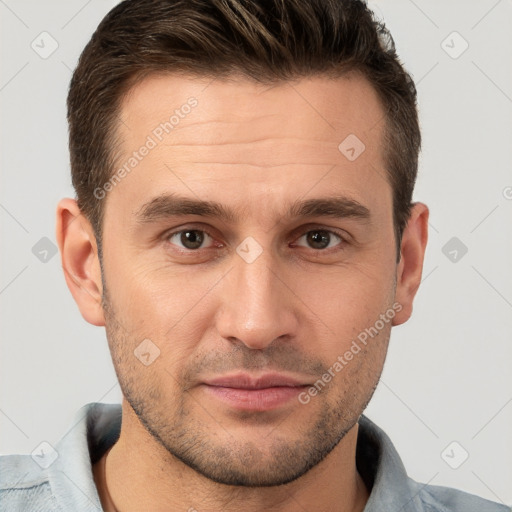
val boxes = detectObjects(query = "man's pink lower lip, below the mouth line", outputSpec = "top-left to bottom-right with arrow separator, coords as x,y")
204,385 -> 307,411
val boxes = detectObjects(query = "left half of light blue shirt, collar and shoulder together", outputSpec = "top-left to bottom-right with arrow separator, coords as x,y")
0,403 -> 122,512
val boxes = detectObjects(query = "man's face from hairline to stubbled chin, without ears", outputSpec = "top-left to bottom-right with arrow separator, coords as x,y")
98,75 -> 397,486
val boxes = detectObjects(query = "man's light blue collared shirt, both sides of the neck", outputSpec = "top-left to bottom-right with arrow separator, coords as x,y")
0,403 -> 511,512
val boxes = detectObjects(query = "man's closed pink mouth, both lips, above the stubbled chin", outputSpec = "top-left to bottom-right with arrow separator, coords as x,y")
201,373 -> 311,411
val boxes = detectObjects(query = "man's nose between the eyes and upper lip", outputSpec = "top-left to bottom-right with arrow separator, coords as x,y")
216,245 -> 298,350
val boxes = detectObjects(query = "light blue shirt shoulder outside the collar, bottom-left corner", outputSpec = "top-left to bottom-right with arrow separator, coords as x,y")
0,455 -> 61,512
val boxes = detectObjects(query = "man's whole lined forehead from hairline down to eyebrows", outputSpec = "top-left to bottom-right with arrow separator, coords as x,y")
108,74 -> 390,224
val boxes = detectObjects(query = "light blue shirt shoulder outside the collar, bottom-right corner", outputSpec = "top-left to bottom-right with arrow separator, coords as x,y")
412,481 -> 512,512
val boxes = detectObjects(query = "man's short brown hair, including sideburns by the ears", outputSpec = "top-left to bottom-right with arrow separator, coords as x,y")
67,0 -> 421,254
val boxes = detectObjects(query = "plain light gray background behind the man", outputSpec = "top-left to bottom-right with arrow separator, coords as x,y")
0,0 -> 512,505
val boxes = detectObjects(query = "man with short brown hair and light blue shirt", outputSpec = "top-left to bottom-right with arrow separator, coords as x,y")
0,0 -> 507,512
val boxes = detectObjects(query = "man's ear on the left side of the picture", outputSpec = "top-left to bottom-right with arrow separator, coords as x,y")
56,198 -> 105,326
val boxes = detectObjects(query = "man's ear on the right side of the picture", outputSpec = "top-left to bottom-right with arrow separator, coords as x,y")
393,203 -> 429,325
